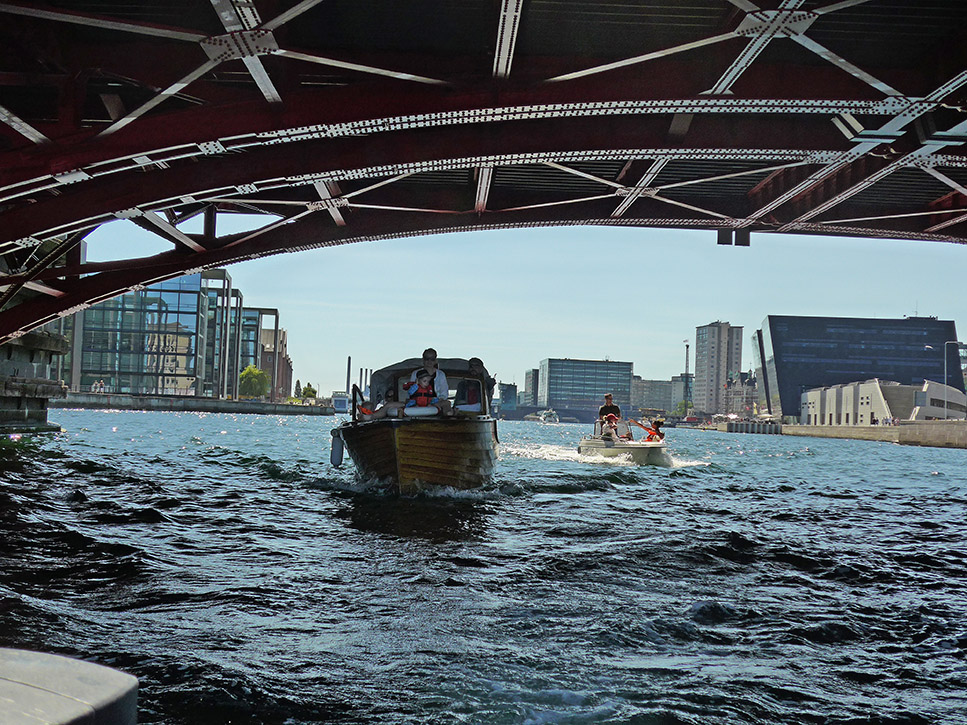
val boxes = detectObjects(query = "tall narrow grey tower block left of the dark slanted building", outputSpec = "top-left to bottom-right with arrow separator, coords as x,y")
692,321 -> 742,414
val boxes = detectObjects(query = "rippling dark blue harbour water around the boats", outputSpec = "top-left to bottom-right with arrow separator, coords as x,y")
0,411 -> 967,724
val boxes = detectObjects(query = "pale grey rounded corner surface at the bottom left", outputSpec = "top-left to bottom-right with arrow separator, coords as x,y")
0,649 -> 138,725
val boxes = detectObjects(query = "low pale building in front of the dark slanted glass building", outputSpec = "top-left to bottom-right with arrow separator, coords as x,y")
799,379 -> 967,426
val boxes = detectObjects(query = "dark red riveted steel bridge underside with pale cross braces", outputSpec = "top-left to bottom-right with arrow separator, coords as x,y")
0,0 -> 967,342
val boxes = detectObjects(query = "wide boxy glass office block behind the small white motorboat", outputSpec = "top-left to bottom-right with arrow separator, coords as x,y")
537,358 -> 632,412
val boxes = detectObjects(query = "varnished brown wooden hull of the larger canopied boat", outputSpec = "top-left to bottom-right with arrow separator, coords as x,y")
335,416 -> 497,494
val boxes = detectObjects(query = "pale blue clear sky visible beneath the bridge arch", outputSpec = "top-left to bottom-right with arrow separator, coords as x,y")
87,217 -> 967,395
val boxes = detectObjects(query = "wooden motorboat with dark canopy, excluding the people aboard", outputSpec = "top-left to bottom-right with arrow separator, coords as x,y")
331,358 -> 497,494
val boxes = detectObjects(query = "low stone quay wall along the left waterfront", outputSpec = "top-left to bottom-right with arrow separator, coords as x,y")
48,393 -> 335,415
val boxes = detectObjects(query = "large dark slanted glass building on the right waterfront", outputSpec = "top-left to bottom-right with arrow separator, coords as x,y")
752,315 -> 964,419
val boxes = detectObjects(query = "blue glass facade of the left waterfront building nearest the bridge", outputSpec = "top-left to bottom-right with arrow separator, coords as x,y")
78,274 -> 208,395
